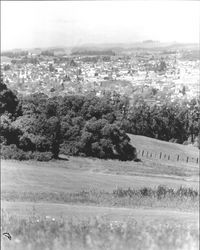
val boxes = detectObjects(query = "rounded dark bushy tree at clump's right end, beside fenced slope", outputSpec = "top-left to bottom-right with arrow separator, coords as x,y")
79,118 -> 136,160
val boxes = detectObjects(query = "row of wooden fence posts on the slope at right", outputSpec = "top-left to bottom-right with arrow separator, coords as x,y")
137,149 -> 199,164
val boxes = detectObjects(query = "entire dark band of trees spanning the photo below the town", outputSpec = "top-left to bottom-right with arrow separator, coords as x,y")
0,77 -> 200,160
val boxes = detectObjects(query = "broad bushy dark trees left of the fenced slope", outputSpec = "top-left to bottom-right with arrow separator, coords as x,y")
0,78 -> 136,160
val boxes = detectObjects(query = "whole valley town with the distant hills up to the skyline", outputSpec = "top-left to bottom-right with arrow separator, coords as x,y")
1,41 -> 200,105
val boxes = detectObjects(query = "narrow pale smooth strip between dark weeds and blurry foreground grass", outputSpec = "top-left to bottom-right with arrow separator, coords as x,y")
2,201 -> 199,223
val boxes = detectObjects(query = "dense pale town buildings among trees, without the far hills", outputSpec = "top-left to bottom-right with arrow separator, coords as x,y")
1,51 -> 200,103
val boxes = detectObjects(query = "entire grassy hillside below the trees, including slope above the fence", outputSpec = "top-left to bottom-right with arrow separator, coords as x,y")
1,136 -> 199,250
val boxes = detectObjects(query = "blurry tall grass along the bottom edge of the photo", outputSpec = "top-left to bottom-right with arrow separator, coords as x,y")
2,212 -> 199,250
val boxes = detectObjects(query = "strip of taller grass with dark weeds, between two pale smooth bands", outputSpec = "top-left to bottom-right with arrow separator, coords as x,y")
1,186 -> 199,211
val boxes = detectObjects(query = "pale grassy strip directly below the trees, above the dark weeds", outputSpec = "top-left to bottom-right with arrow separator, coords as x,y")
1,157 -> 199,192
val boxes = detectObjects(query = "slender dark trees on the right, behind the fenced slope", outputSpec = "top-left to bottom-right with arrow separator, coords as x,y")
122,96 -> 200,146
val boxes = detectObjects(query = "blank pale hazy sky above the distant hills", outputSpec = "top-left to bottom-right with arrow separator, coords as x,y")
1,1 -> 200,50
